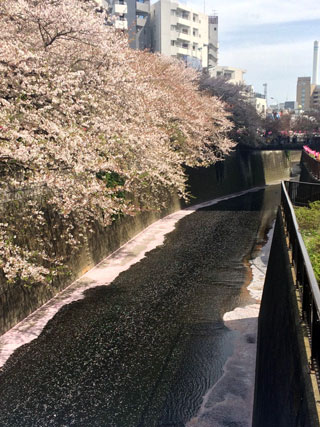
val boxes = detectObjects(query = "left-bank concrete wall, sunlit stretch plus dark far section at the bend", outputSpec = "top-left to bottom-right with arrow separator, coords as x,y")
0,151 -> 296,335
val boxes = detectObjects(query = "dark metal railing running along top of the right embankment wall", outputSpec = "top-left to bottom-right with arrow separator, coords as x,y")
281,181 -> 320,386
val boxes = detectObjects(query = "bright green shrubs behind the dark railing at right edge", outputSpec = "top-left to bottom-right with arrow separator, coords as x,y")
295,201 -> 320,283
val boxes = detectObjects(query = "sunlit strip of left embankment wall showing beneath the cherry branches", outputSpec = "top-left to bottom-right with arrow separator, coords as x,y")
0,190 -> 180,335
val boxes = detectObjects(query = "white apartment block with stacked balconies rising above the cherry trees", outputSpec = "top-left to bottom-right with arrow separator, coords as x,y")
150,0 -> 218,70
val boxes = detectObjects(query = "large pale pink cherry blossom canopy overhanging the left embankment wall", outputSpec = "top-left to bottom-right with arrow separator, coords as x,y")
0,0 -> 233,288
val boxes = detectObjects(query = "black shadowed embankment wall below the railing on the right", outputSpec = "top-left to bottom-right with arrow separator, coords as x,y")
253,209 -> 319,427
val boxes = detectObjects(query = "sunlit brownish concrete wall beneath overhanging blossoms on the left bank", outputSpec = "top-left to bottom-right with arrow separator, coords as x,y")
0,196 -> 180,335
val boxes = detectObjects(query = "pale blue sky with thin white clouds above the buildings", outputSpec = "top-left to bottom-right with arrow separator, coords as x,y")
184,0 -> 320,104
